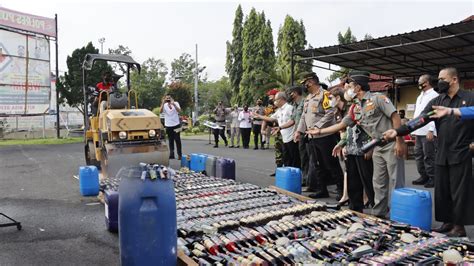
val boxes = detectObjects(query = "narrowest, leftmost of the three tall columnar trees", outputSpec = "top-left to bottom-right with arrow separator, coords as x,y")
225,5 -> 244,103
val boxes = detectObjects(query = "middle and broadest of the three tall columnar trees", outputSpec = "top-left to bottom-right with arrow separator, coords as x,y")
236,8 -> 275,105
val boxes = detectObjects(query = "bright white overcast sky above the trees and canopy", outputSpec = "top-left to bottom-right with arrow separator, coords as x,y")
0,0 -> 474,84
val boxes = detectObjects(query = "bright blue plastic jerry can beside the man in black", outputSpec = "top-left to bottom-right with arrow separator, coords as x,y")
390,188 -> 432,231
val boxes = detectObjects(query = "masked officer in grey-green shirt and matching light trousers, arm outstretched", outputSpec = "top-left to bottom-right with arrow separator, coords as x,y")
308,71 -> 406,218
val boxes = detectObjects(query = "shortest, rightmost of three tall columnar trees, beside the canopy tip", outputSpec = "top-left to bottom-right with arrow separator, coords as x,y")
277,15 -> 312,73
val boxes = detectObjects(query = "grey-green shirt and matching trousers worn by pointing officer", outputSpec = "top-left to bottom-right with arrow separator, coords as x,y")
342,92 -> 405,216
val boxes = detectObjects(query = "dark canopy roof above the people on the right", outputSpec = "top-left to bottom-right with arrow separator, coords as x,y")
295,16 -> 474,77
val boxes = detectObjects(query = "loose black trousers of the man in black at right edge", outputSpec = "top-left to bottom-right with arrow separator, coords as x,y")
435,160 -> 474,225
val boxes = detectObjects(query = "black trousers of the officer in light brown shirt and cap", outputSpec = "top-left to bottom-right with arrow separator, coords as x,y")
307,134 -> 343,191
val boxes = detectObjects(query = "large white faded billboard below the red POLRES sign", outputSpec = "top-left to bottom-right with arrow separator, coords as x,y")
0,30 -> 51,114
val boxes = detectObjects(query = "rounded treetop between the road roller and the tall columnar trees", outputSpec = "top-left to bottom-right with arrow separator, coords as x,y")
170,53 -> 206,84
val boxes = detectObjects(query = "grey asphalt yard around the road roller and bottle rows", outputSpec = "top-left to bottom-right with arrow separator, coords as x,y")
0,138 -> 474,265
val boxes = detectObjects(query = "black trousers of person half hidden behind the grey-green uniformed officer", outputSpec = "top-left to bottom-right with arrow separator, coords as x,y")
346,155 -> 374,212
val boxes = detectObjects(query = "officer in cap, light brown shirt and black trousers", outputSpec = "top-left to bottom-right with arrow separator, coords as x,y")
295,73 -> 343,200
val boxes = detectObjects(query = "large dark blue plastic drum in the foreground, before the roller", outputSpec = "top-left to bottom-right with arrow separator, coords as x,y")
119,167 -> 177,265
